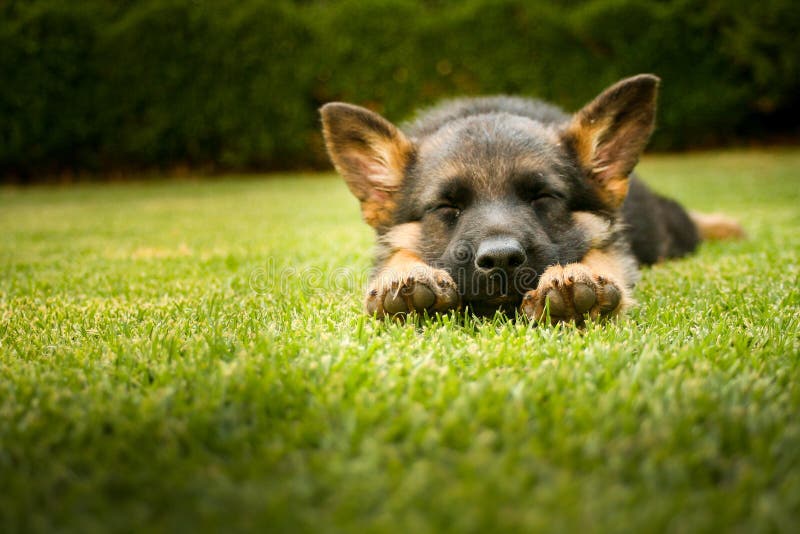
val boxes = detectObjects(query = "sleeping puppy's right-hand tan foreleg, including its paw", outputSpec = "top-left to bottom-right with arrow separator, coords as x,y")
522,247 -> 637,325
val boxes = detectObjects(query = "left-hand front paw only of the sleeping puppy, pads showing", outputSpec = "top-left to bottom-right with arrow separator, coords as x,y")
366,264 -> 460,317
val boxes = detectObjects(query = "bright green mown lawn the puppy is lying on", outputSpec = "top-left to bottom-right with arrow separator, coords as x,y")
0,150 -> 800,533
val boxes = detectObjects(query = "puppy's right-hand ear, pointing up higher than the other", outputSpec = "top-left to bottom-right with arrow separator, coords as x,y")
562,74 -> 660,209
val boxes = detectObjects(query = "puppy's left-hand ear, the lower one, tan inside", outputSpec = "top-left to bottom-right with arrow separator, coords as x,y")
320,102 -> 414,230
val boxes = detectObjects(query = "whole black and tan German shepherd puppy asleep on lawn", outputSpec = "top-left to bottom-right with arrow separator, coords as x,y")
321,74 -> 741,324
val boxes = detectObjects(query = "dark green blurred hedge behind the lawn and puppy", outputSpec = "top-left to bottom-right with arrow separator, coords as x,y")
0,0 -> 800,181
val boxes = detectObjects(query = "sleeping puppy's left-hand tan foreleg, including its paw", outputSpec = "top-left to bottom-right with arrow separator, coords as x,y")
365,223 -> 459,317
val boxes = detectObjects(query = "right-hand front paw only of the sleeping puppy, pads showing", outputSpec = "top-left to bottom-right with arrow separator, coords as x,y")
522,263 -> 624,325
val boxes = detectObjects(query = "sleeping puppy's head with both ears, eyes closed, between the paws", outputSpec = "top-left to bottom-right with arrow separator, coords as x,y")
322,75 -> 659,314
